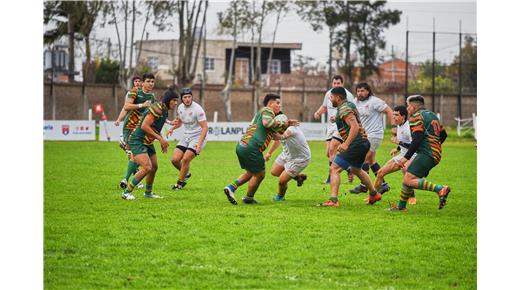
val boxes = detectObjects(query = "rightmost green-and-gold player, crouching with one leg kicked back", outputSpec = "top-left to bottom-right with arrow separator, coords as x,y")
388,95 -> 451,211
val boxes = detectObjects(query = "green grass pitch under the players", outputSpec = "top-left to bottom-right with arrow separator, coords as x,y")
44,138 -> 477,289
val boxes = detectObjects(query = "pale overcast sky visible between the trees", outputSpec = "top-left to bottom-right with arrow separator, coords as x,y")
87,1 -> 477,64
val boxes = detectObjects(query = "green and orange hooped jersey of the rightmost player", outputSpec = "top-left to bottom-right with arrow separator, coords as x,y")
408,109 -> 444,164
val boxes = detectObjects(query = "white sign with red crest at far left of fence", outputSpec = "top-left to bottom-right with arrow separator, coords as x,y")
43,120 -> 96,141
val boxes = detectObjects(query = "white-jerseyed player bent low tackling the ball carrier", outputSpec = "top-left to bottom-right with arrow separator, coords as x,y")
265,114 -> 311,201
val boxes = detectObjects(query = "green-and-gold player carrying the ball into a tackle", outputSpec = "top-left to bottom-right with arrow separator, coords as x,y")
224,94 -> 300,205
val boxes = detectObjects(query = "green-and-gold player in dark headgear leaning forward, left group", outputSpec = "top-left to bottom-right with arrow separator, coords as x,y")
121,88 -> 179,200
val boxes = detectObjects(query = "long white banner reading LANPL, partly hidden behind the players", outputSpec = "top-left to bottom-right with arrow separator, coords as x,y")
99,122 -> 326,141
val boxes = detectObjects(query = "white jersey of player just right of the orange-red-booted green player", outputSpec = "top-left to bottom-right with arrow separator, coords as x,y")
354,96 -> 387,139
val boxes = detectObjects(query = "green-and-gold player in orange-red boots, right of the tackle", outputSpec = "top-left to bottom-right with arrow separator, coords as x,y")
319,87 -> 381,207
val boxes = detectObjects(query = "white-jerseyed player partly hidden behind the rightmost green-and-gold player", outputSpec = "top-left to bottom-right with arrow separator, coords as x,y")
374,106 -> 417,204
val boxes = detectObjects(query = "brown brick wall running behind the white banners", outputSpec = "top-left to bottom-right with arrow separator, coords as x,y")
43,83 -> 477,126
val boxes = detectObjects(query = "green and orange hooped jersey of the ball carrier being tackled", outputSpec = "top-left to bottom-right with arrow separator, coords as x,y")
240,107 -> 287,152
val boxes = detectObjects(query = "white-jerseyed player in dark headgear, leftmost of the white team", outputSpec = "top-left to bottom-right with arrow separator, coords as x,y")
167,88 -> 208,190
